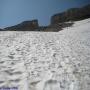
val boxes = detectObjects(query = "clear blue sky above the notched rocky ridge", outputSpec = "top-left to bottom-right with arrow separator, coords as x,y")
0,0 -> 90,28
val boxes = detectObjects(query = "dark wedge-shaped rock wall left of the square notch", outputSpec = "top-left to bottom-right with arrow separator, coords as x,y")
5,20 -> 39,31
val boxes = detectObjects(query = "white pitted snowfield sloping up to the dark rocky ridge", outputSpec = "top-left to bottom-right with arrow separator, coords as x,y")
0,19 -> 90,90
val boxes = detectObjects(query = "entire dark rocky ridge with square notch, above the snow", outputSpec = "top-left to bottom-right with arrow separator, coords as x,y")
4,5 -> 90,32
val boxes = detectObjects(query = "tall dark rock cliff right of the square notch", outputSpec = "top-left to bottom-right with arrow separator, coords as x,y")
51,5 -> 90,24
